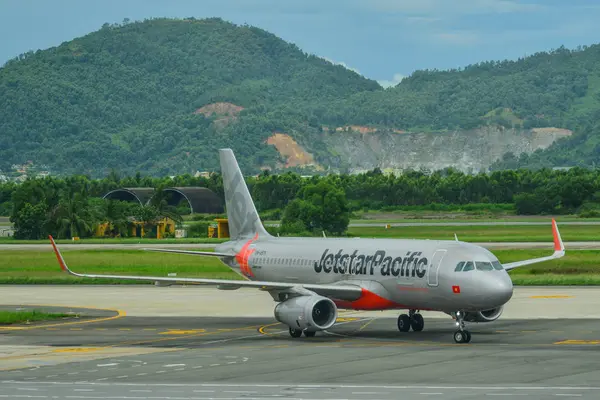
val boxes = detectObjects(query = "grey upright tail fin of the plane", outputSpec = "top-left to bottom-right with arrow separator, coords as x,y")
219,149 -> 270,239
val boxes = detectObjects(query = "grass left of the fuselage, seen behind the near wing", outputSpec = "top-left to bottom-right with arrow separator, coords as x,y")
0,250 -> 240,284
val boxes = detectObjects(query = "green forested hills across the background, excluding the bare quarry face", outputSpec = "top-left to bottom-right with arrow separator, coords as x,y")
0,19 -> 600,176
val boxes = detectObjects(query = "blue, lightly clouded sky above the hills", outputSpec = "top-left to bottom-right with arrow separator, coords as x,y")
0,0 -> 600,86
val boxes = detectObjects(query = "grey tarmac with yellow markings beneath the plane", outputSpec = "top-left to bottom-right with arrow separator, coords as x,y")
0,286 -> 600,400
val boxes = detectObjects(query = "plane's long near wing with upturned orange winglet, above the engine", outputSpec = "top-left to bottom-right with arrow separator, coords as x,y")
49,236 -> 363,301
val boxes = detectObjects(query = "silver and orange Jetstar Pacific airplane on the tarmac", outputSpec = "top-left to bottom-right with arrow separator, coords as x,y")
49,149 -> 565,343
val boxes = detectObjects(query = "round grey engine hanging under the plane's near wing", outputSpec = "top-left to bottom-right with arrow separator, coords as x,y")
275,295 -> 337,331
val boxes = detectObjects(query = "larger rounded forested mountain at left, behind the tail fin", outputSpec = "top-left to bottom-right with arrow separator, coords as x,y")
0,19 -> 381,174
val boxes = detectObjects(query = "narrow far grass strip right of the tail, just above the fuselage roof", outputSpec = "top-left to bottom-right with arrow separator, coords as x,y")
348,225 -> 600,242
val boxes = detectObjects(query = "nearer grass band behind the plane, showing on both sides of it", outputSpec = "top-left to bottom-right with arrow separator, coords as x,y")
0,249 -> 600,285
